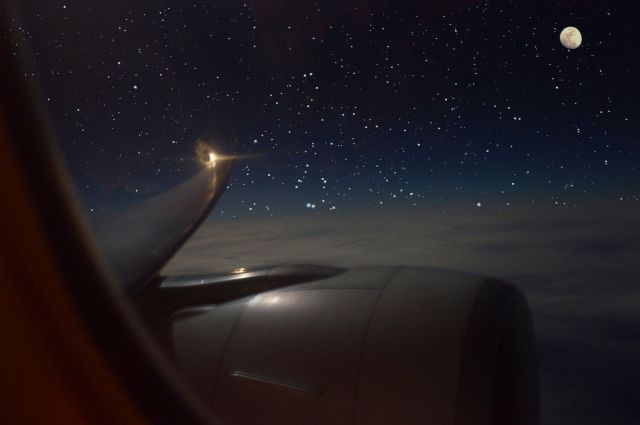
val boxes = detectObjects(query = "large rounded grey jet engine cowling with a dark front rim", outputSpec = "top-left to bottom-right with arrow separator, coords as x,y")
171,267 -> 538,425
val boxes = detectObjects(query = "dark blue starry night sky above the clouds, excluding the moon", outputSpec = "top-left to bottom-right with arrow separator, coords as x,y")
13,0 -> 640,218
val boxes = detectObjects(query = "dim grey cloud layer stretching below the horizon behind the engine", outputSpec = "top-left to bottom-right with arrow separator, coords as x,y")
165,204 -> 640,425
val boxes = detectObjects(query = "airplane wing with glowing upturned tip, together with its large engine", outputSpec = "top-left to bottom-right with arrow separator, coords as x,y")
87,156 -> 539,425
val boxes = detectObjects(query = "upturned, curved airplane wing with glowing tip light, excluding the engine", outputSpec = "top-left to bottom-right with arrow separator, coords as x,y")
93,160 -> 233,294
